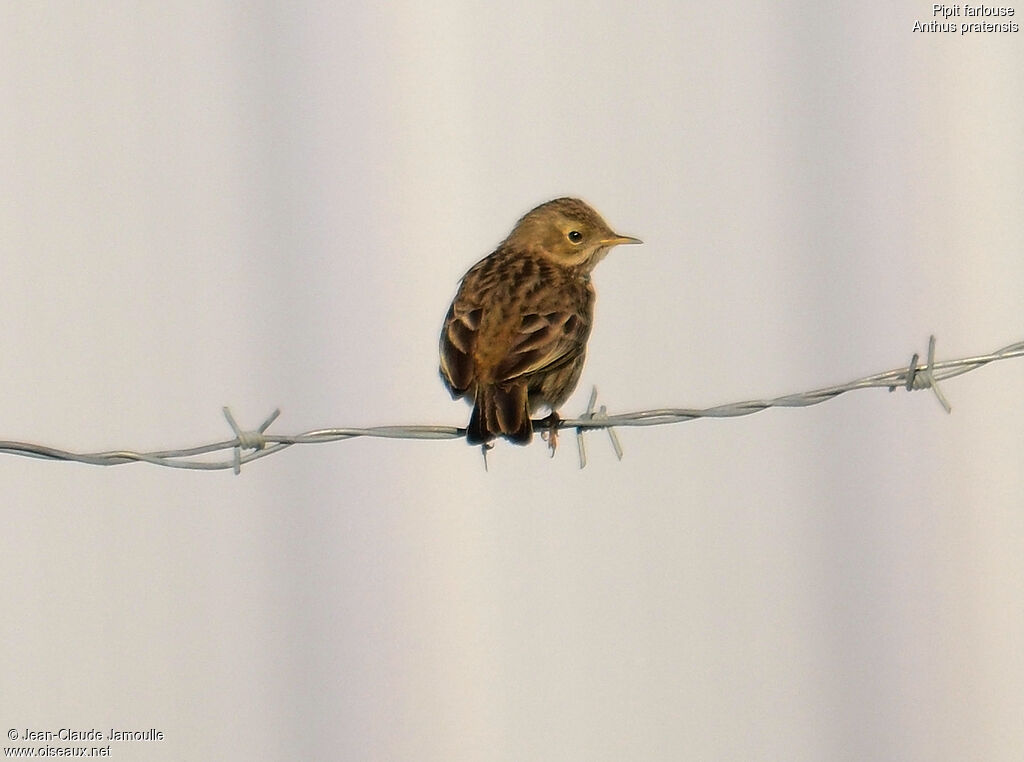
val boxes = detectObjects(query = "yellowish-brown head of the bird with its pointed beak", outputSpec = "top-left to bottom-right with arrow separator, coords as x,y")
505,199 -> 643,271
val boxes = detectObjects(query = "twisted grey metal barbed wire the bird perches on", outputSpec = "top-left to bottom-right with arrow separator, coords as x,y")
0,336 -> 1024,473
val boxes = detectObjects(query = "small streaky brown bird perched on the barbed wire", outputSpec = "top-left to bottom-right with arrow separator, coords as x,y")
440,199 -> 641,450
